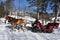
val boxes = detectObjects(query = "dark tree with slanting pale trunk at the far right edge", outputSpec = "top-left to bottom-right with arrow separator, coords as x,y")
50,0 -> 60,23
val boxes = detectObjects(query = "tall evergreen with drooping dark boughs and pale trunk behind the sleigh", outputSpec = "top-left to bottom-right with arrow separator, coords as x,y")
27,0 -> 48,24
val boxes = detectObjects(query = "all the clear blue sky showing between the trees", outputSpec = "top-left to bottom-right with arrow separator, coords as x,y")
1,0 -> 53,13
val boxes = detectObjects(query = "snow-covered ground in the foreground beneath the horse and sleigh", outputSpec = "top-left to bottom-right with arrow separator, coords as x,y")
0,23 -> 60,40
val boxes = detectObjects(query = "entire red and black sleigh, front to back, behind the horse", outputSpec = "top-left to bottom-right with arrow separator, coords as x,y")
32,23 -> 59,33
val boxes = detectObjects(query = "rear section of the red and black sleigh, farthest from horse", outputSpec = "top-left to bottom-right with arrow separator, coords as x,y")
42,23 -> 59,33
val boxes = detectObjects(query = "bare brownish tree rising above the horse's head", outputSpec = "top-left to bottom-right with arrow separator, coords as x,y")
4,0 -> 14,16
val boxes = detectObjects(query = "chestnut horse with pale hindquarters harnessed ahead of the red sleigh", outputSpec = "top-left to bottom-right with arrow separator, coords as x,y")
6,16 -> 26,31
